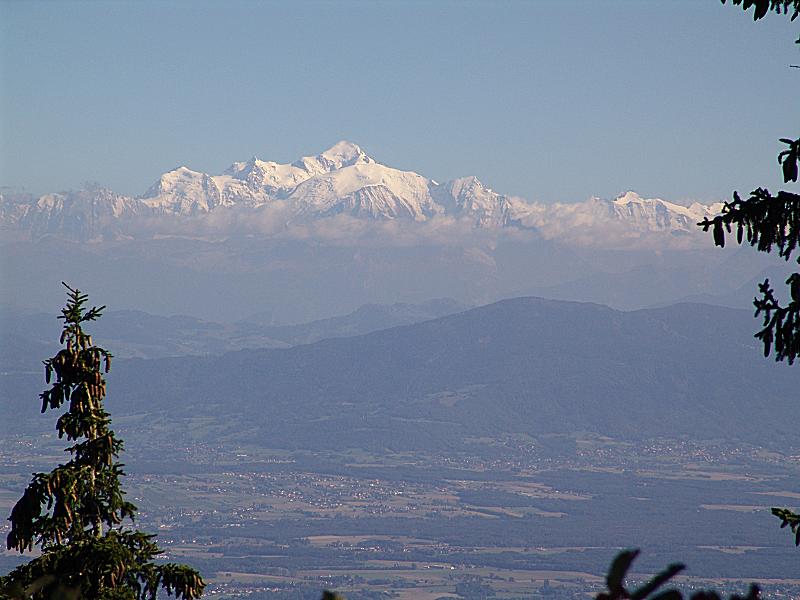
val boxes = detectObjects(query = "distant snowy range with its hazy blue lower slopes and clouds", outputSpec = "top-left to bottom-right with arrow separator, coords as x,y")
0,142 -> 764,326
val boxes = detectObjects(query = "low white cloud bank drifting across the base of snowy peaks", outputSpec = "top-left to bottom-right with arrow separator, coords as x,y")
125,198 -> 720,250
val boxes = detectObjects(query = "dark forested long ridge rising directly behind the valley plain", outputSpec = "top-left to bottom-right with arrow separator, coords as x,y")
0,298 -> 797,450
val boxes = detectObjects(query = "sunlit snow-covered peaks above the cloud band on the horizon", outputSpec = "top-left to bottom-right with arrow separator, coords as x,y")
0,141 -> 721,241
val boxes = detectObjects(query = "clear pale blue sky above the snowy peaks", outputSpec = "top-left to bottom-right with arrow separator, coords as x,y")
0,0 -> 800,201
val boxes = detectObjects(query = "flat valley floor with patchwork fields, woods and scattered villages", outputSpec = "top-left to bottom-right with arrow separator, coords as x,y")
0,430 -> 800,600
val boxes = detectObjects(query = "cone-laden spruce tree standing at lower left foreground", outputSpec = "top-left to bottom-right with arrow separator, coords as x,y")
0,284 -> 205,600
